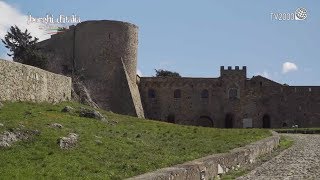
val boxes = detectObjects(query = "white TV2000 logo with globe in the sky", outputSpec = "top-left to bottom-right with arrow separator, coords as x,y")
270,7 -> 307,21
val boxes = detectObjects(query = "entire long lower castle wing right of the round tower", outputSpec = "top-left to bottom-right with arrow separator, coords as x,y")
139,67 -> 320,128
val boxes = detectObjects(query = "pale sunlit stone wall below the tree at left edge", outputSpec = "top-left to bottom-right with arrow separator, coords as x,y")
0,60 -> 71,102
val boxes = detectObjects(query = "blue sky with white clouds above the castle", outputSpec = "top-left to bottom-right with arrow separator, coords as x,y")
0,0 -> 320,85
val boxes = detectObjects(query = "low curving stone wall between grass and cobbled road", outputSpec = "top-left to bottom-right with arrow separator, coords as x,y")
130,132 -> 280,180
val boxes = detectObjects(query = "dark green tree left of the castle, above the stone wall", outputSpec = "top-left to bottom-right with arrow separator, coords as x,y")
1,26 -> 47,69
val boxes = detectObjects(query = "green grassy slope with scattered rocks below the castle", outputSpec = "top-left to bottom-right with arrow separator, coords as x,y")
0,102 -> 270,179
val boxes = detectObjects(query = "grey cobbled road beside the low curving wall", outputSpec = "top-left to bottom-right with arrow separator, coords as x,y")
238,134 -> 320,180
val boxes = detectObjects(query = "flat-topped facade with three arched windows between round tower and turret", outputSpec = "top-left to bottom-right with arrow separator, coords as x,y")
139,77 -> 222,126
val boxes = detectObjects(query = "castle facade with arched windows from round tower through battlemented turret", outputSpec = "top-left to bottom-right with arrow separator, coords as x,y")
140,67 -> 252,127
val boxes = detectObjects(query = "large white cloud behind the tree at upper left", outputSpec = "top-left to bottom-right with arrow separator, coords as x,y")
0,1 -> 50,41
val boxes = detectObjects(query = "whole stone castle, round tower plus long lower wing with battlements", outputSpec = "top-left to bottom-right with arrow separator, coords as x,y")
39,20 -> 320,128
